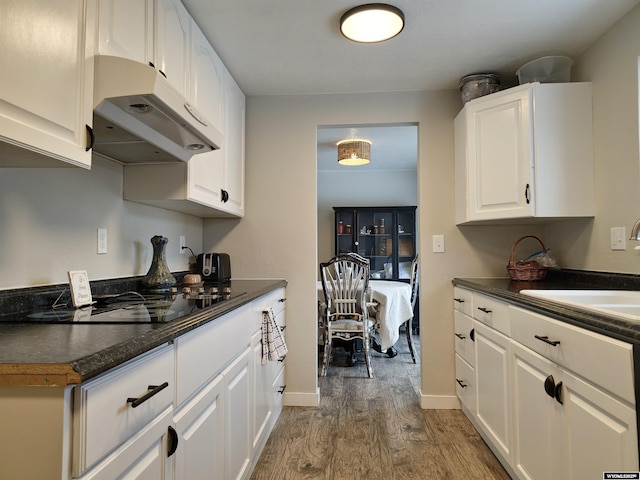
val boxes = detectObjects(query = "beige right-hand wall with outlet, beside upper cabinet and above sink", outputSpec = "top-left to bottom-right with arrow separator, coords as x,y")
546,6 -> 640,274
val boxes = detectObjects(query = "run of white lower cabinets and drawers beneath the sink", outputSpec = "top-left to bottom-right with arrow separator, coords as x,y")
455,291 -> 638,480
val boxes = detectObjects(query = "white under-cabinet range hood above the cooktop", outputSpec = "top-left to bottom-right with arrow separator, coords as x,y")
93,55 -> 222,164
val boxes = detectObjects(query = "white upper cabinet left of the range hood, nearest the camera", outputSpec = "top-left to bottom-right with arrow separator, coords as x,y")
0,0 -> 95,168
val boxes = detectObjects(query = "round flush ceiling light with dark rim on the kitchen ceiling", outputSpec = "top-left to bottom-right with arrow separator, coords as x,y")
340,3 -> 404,43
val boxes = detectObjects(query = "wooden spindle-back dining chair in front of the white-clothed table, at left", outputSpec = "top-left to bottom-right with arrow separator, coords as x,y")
320,253 -> 374,378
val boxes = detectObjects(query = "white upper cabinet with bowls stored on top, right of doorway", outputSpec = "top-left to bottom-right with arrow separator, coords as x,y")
455,83 -> 595,225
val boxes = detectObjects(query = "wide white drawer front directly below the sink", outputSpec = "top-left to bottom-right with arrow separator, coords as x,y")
509,306 -> 635,404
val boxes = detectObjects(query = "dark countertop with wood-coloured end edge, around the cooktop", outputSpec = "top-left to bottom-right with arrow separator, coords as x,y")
0,279 -> 287,386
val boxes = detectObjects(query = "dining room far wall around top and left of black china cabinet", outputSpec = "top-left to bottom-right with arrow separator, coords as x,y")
318,169 -> 418,262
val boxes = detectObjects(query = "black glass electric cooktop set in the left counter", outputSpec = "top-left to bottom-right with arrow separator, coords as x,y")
2,285 -> 247,323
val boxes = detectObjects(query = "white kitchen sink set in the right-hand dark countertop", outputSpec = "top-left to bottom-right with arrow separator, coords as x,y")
520,290 -> 640,322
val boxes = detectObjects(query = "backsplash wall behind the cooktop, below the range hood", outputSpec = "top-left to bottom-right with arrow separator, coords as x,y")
0,155 -> 203,290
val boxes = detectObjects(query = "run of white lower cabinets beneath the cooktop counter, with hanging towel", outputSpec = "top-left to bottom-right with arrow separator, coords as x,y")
0,288 -> 285,480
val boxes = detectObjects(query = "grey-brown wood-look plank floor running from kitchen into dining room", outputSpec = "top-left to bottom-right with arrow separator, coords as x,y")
251,334 -> 509,480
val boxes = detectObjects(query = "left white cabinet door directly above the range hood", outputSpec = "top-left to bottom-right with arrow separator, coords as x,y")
98,0 -> 155,64
